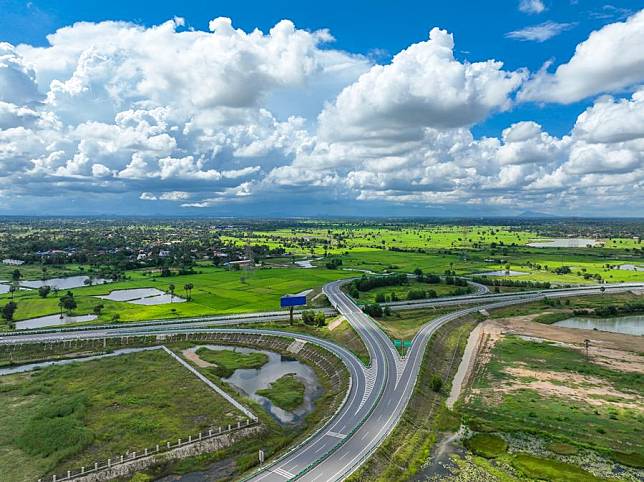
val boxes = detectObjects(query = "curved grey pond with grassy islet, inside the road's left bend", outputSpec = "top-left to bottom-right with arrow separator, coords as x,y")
189,345 -> 323,425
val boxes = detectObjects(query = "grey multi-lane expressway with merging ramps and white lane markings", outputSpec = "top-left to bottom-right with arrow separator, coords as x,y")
0,280 -> 644,482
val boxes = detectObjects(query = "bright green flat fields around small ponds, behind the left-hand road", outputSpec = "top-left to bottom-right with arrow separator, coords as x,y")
0,267 -> 351,327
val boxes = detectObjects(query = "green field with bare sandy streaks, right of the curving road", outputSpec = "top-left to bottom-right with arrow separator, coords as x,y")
463,336 -> 644,457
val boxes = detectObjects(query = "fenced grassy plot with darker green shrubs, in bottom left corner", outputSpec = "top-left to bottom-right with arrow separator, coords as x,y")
0,350 -> 241,481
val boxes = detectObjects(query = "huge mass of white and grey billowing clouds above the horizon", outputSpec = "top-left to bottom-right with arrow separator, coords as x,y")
0,8 -> 644,214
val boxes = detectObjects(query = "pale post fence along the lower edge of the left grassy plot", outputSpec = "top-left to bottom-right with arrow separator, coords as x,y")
38,418 -> 258,482
